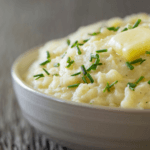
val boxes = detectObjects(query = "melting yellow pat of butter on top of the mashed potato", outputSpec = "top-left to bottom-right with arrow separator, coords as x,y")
108,27 -> 150,61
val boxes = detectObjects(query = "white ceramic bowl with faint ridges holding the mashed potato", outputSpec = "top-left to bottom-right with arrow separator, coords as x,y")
11,48 -> 150,150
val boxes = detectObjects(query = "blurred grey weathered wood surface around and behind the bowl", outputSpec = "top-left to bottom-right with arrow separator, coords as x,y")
0,0 -> 150,150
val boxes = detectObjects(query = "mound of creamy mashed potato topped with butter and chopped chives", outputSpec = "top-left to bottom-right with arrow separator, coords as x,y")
25,13 -> 150,109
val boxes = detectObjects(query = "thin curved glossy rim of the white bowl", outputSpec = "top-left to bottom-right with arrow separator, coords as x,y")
11,44 -> 150,113
